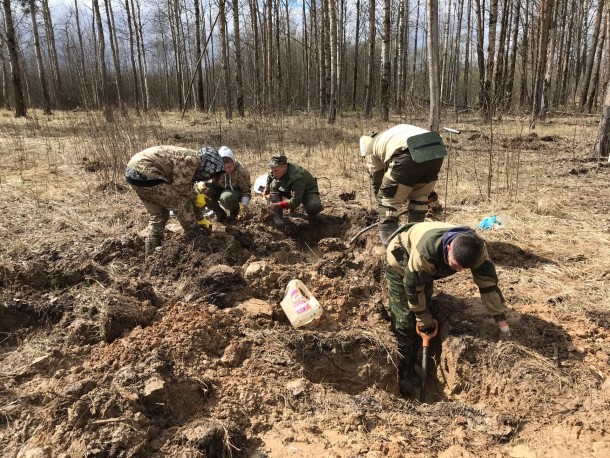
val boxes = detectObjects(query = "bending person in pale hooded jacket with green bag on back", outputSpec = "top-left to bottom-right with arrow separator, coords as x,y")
360,124 -> 447,246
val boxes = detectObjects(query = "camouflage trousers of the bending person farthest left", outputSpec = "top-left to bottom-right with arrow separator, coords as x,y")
130,184 -> 197,241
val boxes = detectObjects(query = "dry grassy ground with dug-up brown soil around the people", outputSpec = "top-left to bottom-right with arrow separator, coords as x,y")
0,112 -> 610,458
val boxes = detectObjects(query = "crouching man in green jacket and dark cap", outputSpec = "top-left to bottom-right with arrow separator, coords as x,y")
263,154 -> 324,227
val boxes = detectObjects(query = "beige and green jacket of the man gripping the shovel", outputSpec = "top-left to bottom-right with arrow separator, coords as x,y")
386,222 -> 506,316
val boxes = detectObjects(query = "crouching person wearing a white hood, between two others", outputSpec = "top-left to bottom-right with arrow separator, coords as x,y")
206,146 -> 252,223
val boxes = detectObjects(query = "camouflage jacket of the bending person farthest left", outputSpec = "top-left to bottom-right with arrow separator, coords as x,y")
127,145 -> 201,187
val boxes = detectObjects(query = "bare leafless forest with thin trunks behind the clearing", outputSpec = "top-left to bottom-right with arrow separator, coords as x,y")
0,0 -> 610,157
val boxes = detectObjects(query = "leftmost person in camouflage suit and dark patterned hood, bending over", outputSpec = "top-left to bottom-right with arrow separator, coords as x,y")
125,145 -> 224,254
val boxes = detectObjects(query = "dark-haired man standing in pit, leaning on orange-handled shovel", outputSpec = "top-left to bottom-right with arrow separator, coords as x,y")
385,222 -> 509,395
